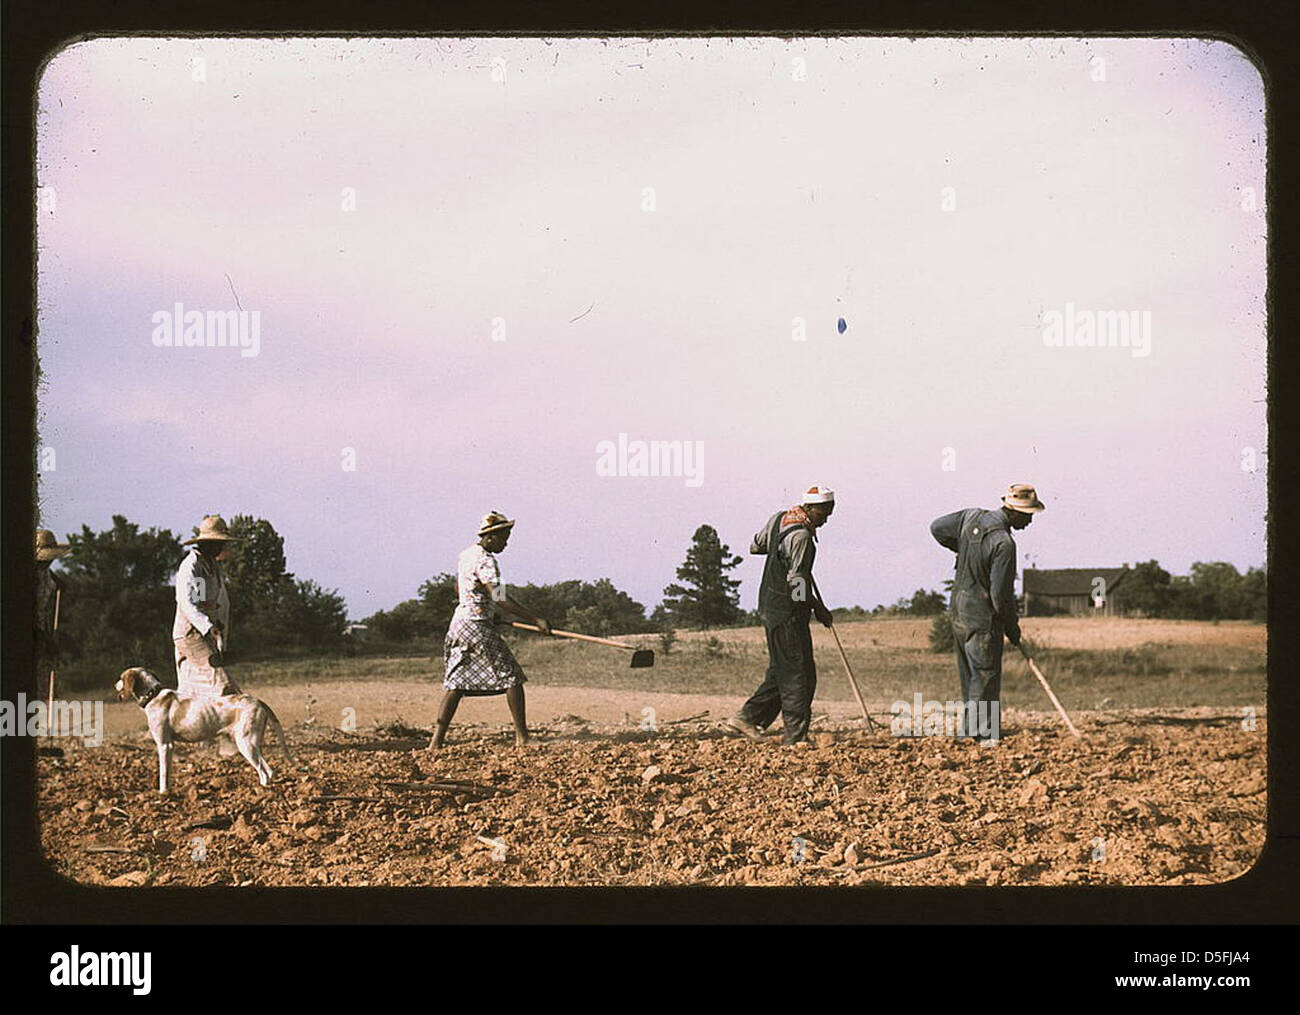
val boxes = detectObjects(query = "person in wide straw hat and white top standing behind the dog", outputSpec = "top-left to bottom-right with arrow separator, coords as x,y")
172,515 -> 239,697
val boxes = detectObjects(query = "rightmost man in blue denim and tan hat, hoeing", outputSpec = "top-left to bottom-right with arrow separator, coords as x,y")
930,483 -> 1044,741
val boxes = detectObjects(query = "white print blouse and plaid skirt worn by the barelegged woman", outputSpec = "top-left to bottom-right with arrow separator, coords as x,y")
442,543 -> 528,695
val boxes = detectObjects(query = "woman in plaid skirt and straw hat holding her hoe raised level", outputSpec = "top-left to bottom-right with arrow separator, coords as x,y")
429,511 -> 551,751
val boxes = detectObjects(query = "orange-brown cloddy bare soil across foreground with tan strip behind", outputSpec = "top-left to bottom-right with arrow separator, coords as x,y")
38,684 -> 1266,885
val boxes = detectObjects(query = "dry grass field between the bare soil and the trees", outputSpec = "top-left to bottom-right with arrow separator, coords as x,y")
220,617 -> 1268,710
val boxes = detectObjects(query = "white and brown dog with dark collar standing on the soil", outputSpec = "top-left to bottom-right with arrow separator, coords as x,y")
117,667 -> 294,793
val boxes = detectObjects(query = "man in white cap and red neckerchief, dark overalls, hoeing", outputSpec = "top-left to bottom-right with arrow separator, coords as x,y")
723,485 -> 835,745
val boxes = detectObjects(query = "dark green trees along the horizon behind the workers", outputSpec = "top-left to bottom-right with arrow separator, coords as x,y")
38,515 -> 1268,684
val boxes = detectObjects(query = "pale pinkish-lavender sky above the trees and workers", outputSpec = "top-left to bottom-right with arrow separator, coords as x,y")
36,38 -> 1268,617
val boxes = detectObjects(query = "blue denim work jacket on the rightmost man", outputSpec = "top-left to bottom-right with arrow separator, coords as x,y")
930,508 -> 1021,638
